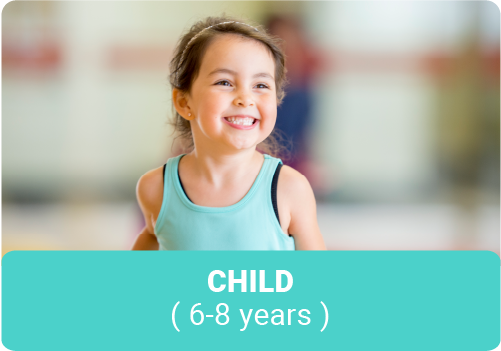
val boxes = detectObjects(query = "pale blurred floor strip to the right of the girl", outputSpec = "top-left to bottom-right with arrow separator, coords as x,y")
318,205 -> 501,254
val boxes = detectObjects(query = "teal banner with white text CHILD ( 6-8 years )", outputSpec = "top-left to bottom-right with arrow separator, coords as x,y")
2,251 -> 501,351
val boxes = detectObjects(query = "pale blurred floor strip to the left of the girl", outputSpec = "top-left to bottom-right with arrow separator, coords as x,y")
2,203 -> 141,256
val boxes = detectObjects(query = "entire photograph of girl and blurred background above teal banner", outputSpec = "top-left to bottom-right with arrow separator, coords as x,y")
1,0 -> 501,256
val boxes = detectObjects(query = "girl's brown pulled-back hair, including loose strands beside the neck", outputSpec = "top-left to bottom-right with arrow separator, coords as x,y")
169,17 -> 287,157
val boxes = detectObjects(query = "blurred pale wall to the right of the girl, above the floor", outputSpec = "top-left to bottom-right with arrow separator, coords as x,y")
305,0 -> 501,203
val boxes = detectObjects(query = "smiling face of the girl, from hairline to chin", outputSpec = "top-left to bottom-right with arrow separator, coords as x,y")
187,34 -> 277,155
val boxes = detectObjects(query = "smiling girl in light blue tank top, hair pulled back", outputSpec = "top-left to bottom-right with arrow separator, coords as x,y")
133,17 -> 325,250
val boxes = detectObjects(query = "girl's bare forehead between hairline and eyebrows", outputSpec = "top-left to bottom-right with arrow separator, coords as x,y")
200,34 -> 275,76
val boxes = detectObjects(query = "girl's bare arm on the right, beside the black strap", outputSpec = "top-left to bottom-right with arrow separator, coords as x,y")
278,166 -> 326,250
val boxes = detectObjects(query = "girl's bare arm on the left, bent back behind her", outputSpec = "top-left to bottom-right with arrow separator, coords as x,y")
132,167 -> 163,250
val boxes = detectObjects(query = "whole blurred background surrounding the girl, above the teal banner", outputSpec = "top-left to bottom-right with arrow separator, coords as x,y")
1,0 -> 501,255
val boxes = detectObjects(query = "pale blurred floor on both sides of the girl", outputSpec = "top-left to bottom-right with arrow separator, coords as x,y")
2,203 -> 501,255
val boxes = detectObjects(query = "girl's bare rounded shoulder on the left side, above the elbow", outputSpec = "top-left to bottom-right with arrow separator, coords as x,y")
136,165 -> 164,216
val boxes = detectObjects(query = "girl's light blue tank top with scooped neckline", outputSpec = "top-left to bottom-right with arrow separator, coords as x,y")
155,155 -> 294,250
